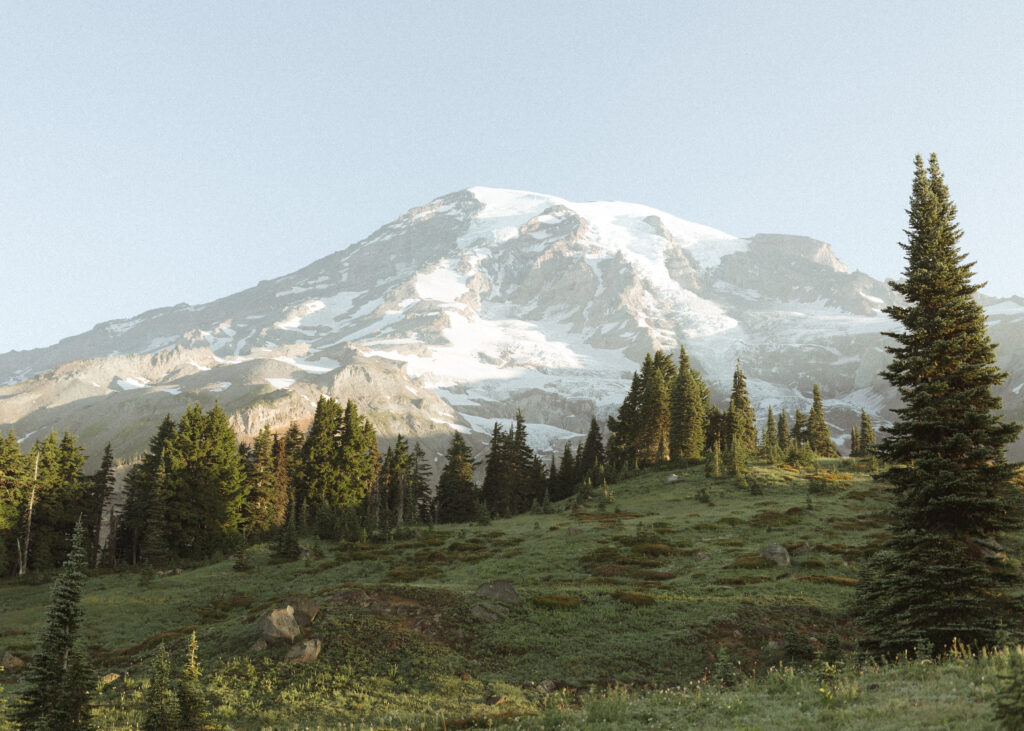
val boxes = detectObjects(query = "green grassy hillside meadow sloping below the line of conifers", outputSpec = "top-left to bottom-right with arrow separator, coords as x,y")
0,463 -> 1019,729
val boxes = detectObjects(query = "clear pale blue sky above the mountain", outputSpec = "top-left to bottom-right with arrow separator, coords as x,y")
0,0 -> 1024,352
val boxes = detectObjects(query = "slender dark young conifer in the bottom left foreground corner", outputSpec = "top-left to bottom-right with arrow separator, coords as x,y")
14,519 -> 95,731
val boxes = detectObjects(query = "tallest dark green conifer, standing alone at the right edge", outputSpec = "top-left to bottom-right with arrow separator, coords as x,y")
855,156 -> 1024,653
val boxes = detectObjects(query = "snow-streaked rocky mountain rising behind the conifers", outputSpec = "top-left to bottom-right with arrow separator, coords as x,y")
0,187 -> 1024,456
